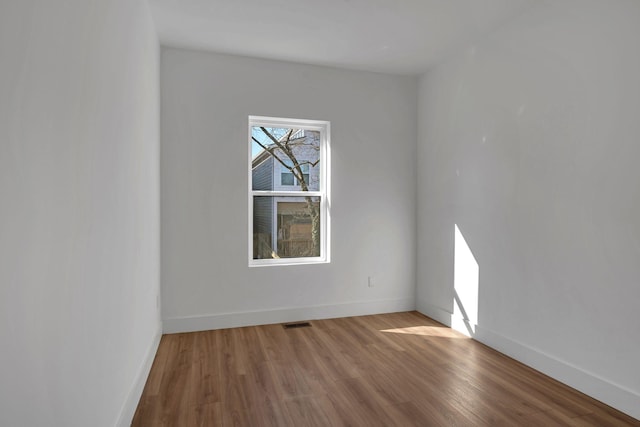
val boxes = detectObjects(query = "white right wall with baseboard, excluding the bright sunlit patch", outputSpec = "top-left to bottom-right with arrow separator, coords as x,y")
417,0 -> 640,418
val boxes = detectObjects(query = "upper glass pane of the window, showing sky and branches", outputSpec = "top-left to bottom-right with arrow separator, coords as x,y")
251,126 -> 320,191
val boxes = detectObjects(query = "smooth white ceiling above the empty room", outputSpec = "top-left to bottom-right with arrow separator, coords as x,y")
149,0 -> 537,74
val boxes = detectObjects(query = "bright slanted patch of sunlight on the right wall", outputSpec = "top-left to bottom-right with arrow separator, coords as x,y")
451,224 -> 480,337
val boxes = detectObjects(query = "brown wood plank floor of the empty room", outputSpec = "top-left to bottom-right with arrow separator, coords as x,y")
132,312 -> 640,427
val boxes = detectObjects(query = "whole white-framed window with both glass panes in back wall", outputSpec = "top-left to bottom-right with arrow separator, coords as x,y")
248,116 -> 329,266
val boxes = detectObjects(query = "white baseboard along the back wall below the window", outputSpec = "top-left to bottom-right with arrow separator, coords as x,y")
162,298 -> 415,334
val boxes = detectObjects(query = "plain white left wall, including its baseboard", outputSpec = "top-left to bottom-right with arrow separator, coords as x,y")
0,0 -> 160,427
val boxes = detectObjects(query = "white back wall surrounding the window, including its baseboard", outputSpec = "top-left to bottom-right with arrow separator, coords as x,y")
161,49 -> 417,332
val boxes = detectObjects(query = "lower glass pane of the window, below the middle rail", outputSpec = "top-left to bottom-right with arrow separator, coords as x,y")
253,196 -> 321,259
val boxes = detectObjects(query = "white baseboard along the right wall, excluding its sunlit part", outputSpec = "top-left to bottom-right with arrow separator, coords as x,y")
416,303 -> 640,420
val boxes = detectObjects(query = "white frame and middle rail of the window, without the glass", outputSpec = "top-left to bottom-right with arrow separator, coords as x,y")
247,116 -> 331,267
